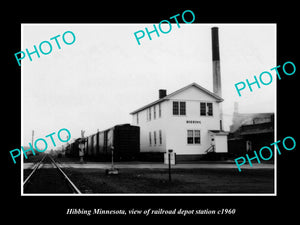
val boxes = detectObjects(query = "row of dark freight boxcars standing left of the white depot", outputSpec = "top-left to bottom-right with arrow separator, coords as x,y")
66,124 -> 140,161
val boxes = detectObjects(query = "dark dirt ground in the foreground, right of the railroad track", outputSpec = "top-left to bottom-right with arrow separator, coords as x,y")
64,168 -> 274,194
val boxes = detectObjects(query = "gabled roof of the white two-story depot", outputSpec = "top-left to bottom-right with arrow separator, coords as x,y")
130,83 -> 224,114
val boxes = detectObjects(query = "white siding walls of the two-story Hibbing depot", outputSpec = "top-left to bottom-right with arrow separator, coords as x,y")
133,84 -> 227,155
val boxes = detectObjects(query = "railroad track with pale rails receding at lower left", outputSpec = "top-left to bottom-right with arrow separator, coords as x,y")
23,154 -> 81,194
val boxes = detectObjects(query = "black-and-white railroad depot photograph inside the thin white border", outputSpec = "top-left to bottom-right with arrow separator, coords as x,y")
20,23 -> 276,195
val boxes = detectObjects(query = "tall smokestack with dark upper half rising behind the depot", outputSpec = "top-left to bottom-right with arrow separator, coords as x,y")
211,27 -> 223,130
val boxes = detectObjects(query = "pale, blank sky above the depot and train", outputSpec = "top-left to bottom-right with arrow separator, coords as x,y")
21,22 -> 277,148
